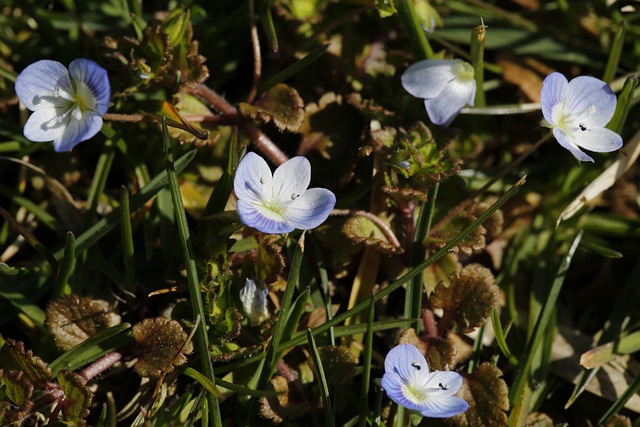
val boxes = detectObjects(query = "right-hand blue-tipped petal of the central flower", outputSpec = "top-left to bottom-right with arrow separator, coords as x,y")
284,188 -> 336,230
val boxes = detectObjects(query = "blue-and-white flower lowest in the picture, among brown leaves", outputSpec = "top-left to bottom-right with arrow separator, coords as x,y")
382,344 -> 469,418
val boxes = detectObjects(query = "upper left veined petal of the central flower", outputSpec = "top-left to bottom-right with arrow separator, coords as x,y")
233,152 -> 273,206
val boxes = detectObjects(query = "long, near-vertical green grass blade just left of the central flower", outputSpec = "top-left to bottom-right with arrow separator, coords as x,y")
162,118 -> 222,427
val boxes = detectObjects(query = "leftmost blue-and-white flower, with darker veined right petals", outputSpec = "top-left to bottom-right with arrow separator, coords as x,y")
16,59 -> 111,152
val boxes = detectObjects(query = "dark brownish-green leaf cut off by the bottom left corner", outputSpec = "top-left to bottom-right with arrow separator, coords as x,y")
0,369 -> 33,426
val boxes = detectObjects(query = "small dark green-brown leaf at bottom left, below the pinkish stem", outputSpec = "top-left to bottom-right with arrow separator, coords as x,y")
58,370 -> 93,426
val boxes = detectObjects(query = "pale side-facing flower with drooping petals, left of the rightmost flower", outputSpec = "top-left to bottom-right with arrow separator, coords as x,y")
401,59 -> 476,126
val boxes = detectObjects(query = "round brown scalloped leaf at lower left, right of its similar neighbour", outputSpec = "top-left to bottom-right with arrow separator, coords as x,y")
132,317 -> 193,377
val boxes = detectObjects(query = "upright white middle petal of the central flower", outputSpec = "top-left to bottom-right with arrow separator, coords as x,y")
272,156 -> 311,202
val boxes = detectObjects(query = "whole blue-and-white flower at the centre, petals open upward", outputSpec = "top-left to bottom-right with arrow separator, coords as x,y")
233,153 -> 336,234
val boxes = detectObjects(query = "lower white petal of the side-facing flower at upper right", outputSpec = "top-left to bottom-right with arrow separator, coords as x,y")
424,80 -> 476,126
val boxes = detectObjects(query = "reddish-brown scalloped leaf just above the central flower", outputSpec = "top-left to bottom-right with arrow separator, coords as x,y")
238,83 -> 304,132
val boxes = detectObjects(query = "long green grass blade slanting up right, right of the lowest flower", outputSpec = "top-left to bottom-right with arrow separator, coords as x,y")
509,232 -> 582,412
